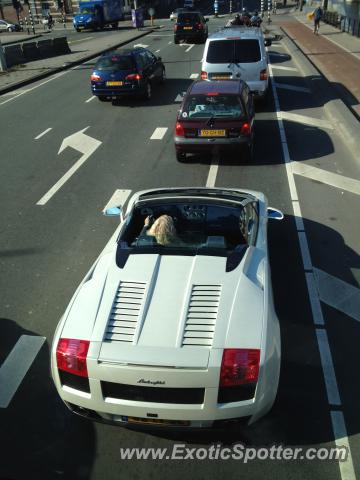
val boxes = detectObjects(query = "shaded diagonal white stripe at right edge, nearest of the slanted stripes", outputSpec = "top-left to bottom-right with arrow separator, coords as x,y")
314,268 -> 360,322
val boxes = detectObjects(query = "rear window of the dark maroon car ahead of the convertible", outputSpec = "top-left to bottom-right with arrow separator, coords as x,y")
183,94 -> 244,119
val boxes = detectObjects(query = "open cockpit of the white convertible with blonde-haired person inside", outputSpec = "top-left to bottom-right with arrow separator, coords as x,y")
118,200 -> 258,256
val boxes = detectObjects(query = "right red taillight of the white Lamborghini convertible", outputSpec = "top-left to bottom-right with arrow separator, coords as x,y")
220,348 -> 260,387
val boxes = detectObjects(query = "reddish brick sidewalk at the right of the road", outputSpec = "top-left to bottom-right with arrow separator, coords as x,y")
277,12 -> 360,118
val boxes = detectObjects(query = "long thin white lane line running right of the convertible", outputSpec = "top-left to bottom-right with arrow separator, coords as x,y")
269,47 -> 356,480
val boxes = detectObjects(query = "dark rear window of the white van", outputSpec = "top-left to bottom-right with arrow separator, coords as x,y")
206,39 -> 261,63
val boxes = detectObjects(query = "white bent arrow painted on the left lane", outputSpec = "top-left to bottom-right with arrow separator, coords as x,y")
36,127 -> 102,205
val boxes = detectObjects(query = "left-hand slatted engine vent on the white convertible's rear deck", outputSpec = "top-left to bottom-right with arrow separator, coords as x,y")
104,282 -> 146,343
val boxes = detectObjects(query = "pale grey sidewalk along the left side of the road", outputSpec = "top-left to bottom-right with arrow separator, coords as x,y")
0,26 -> 160,95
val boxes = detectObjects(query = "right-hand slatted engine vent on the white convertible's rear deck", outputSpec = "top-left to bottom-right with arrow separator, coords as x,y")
182,285 -> 221,347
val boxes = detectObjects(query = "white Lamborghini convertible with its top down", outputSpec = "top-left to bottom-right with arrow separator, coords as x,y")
51,188 -> 283,427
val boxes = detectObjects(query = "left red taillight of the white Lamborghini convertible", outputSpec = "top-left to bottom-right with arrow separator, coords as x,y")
56,338 -> 90,377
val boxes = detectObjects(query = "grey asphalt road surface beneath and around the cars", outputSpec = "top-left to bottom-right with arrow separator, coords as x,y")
0,11 -> 360,480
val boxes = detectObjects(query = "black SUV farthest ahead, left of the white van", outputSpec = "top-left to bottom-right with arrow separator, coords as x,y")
174,12 -> 209,43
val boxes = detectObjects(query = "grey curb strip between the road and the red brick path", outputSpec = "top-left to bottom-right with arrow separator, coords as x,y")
280,26 -> 360,162
